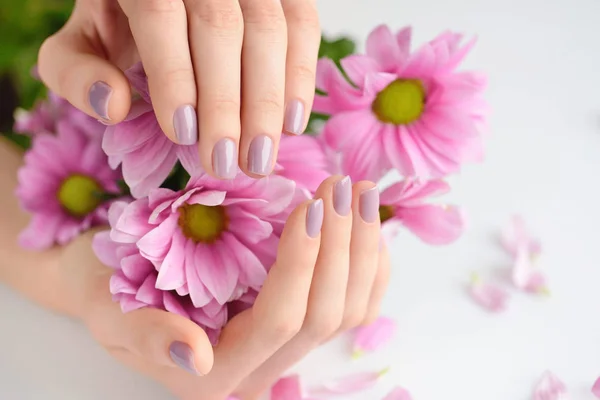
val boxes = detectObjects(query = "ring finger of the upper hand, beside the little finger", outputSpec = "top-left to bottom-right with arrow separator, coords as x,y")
240,0 -> 287,176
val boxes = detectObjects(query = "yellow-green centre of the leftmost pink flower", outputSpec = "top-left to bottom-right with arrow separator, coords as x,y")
58,175 -> 103,217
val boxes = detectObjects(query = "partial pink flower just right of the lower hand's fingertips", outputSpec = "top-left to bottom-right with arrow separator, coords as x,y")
379,178 -> 465,245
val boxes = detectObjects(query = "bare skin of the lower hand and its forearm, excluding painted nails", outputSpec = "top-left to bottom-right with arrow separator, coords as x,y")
0,141 -> 389,400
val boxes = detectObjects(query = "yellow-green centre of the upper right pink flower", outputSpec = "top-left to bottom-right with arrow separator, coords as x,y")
372,79 -> 425,125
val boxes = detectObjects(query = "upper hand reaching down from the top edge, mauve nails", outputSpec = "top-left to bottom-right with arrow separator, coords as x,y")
39,0 -> 320,178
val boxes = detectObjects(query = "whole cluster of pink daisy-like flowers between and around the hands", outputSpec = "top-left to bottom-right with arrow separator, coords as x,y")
15,26 -> 486,341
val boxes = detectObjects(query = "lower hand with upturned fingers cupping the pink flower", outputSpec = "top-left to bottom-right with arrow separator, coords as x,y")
61,177 -> 389,400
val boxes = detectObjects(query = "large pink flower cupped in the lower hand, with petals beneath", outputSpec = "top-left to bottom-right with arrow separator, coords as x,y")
96,174 -> 298,340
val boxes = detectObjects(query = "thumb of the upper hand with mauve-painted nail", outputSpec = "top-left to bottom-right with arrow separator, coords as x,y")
38,27 -> 131,123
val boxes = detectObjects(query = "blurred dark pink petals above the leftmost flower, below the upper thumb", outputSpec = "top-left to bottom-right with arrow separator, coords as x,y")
13,92 -> 106,137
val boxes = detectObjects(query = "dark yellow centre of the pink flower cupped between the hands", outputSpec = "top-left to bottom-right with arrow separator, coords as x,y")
179,204 -> 229,243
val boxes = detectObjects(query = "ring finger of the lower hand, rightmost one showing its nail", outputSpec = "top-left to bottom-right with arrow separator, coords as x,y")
340,182 -> 380,331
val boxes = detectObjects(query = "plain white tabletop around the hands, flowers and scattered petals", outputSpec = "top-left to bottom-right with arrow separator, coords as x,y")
0,0 -> 600,400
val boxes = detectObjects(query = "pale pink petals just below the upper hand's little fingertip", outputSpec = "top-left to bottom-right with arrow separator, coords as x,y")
275,135 -> 331,194
